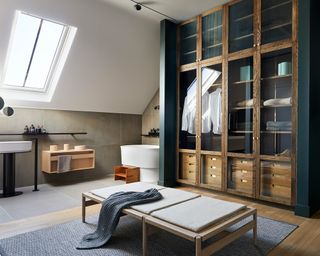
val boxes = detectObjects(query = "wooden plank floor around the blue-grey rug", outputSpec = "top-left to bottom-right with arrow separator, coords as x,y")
0,187 -> 320,256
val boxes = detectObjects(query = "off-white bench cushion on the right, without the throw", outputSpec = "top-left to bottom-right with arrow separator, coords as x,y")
151,196 -> 246,232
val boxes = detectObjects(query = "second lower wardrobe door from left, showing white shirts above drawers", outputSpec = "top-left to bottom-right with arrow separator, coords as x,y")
201,64 -> 222,190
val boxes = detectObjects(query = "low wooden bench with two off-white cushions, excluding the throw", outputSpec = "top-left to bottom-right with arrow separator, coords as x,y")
82,182 -> 257,256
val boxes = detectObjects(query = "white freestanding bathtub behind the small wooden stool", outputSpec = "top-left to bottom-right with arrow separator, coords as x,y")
120,145 -> 159,183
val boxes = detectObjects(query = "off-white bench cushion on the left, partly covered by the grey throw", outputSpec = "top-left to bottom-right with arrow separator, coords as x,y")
90,182 -> 165,198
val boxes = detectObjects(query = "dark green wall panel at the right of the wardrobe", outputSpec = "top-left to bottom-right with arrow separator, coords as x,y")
295,0 -> 320,217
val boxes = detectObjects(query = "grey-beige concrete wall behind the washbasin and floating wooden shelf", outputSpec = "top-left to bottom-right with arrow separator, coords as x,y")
0,108 -> 142,188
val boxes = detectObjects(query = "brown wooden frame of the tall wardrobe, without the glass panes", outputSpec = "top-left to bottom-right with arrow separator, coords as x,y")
176,0 -> 298,206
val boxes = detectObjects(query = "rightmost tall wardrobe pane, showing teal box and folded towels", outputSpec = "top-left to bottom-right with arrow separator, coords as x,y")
260,49 -> 292,157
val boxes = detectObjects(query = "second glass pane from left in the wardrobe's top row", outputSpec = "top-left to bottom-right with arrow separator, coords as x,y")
202,10 -> 223,59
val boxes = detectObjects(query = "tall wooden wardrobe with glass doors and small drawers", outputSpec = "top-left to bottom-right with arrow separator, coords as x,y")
177,0 -> 298,205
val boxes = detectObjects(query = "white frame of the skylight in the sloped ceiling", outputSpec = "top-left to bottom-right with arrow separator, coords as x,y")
1,10 -> 71,93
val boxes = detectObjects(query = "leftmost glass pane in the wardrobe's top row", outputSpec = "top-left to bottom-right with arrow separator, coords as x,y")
180,21 -> 197,65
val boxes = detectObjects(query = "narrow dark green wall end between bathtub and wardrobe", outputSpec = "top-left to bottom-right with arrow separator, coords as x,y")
159,20 -> 177,186
